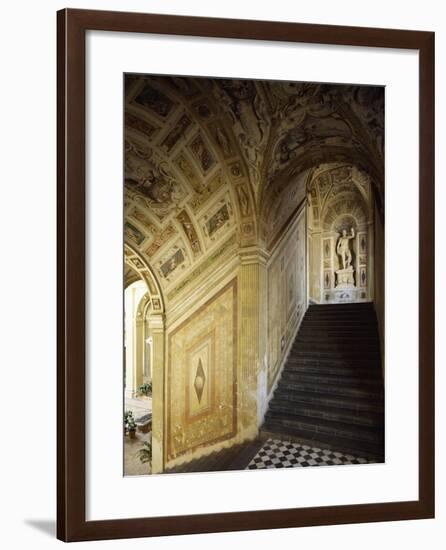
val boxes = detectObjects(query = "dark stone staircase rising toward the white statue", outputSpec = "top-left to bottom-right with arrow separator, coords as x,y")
261,303 -> 384,462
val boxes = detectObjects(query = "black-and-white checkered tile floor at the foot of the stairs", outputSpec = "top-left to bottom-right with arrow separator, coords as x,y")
246,439 -> 369,470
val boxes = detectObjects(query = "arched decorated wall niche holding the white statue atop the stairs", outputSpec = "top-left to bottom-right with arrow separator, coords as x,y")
308,165 -> 374,303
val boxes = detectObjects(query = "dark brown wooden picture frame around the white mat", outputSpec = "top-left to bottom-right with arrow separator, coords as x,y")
57,9 -> 434,541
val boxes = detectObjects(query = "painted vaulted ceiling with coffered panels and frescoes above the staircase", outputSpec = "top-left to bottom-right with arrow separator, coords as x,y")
124,75 -> 384,295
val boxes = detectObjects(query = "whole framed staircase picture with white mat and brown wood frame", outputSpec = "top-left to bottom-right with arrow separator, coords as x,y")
58,10 -> 434,541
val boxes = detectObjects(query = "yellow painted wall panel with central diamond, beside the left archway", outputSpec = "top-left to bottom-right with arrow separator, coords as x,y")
166,280 -> 237,461
